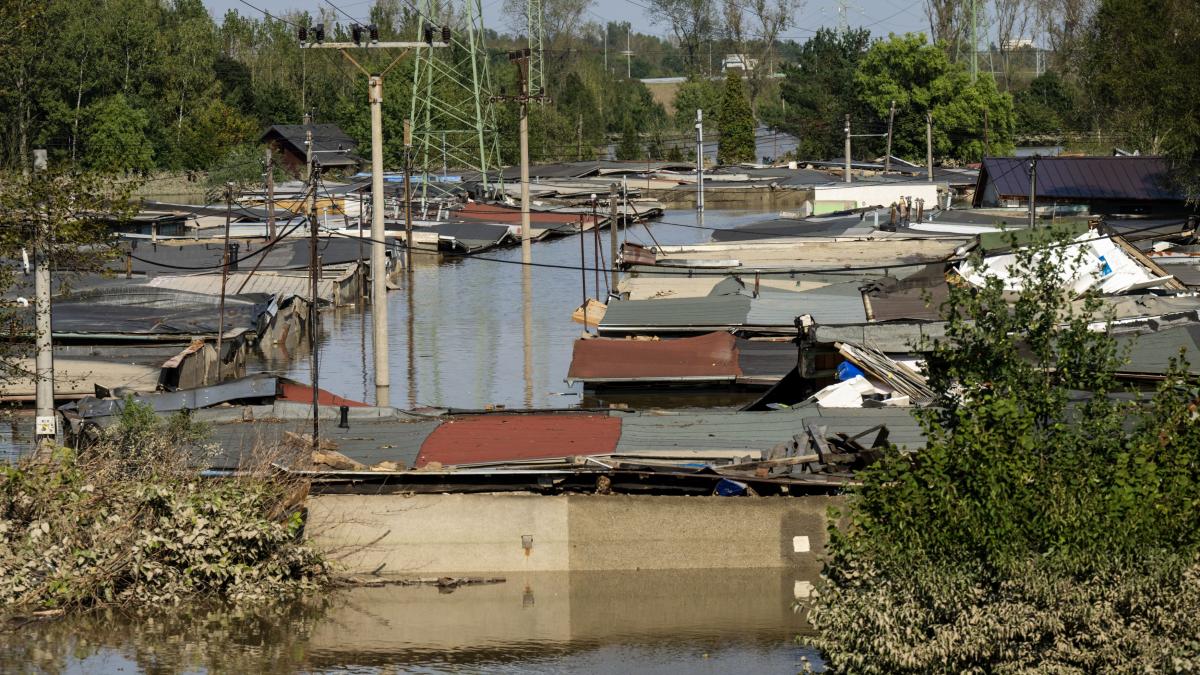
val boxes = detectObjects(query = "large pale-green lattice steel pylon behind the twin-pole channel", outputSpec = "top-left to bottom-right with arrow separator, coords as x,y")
410,0 -> 500,195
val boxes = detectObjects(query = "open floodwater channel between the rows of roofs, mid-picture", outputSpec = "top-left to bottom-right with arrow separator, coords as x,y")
261,210 -> 764,408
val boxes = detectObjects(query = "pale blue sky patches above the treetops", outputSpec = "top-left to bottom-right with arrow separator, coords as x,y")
204,0 -> 929,41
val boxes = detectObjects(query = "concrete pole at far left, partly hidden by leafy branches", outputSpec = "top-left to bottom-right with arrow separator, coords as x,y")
34,150 -> 59,446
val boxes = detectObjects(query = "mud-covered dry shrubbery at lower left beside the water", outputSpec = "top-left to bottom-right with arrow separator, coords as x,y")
0,400 -> 328,613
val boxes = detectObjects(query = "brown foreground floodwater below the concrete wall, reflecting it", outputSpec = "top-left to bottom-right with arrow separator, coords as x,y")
0,569 -> 818,675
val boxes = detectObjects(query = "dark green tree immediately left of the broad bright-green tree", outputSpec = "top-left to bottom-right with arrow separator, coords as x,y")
770,28 -> 875,160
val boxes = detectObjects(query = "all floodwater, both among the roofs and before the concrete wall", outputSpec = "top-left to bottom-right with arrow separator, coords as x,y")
0,210 -> 817,675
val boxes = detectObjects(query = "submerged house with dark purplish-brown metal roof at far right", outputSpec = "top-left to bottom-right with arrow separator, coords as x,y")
973,156 -> 1190,215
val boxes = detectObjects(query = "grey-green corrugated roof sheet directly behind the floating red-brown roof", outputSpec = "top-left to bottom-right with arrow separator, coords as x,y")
599,295 -> 750,335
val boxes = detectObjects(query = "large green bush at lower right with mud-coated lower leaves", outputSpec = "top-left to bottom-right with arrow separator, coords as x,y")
811,228 -> 1200,673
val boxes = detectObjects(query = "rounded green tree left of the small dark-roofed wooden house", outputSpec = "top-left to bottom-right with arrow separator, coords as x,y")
84,94 -> 154,174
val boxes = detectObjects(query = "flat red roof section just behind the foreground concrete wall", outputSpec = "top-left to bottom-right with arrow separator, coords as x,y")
416,414 -> 620,466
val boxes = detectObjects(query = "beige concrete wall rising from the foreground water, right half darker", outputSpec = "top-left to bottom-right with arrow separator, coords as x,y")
307,494 -> 840,575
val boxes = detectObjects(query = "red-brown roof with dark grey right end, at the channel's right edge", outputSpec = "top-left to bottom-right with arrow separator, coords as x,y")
566,333 -> 797,384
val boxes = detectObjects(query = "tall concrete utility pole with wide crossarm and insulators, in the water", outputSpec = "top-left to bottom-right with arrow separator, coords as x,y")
300,24 -> 450,407
